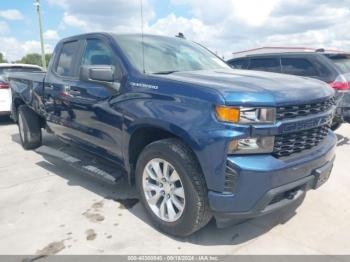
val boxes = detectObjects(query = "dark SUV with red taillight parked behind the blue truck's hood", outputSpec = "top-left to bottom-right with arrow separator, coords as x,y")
227,48 -> 350,130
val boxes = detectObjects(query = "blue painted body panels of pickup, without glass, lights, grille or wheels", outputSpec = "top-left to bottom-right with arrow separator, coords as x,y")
11,33 -> 336,221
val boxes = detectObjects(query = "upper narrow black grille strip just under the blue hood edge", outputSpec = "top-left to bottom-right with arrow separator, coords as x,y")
276,97 -> 335,120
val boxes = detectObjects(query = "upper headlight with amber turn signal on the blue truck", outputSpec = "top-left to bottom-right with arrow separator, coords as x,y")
215,106 -> 276,124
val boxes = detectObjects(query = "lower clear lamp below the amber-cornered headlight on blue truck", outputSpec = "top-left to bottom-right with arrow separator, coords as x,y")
228,136 -> 275,154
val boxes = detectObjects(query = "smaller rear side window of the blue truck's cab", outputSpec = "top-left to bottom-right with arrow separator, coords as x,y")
56,41 -> 79,77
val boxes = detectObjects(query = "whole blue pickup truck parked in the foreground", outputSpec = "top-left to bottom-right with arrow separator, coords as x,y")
9,33 -> 336,236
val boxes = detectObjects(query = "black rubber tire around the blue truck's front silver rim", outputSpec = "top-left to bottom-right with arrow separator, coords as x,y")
135,138 -> 212,237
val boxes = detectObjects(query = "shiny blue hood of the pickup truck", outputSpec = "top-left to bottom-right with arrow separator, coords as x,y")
160,69 -> 334,106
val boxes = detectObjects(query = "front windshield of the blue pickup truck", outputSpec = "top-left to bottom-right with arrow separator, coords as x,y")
115,35 -> 230,74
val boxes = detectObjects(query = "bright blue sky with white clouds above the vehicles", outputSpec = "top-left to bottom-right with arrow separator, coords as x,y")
0,0 -> 350,61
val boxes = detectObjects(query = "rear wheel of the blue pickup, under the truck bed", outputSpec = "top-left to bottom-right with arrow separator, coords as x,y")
18,105 -> 42,149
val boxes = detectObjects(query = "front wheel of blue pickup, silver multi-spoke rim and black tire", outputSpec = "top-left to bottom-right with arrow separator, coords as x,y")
135,139 -> 212,236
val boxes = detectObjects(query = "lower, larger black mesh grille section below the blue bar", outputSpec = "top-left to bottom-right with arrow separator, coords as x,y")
273,126 -> 329,157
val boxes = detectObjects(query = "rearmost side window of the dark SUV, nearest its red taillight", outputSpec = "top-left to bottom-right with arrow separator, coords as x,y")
281,58 -> 319,77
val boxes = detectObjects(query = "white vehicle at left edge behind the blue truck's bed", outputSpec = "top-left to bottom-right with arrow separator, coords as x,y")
0,63 -> 42,116
